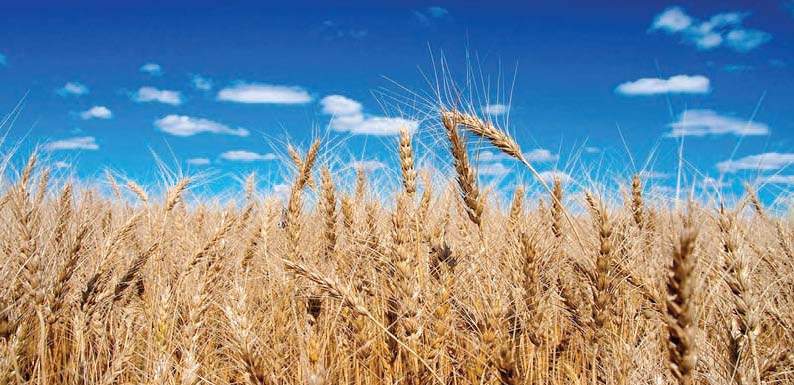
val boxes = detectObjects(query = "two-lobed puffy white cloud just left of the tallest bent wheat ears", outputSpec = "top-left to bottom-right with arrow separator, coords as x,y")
320,95 -> 419,136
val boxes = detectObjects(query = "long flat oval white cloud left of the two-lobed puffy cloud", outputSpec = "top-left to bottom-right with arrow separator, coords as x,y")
218,83 -> 312,104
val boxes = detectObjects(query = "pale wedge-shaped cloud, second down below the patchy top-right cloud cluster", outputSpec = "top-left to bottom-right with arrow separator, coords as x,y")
667,110 -> 769,137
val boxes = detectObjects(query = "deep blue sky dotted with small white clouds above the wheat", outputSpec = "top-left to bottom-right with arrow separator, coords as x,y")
0,0 -> 794,199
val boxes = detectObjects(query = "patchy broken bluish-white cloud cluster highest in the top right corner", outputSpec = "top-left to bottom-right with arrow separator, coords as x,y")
651,7 -> 772,52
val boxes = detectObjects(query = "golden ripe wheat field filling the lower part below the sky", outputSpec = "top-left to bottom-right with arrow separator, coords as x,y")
0,110 -> 794,385
